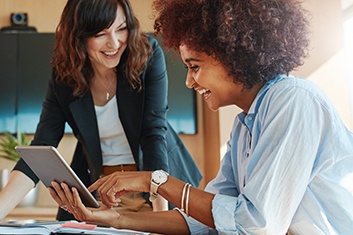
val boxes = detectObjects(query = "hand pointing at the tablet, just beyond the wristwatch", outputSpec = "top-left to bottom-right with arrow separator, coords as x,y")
88,171 -> 152,207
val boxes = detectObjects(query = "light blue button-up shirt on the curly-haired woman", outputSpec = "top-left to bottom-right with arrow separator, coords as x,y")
184,75 -> 353,235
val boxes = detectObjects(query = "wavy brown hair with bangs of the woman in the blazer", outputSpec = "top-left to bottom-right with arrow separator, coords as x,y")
51,0 -> 151,96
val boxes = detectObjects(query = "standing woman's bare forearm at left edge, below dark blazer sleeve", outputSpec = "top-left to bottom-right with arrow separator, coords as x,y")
0,171 -> 35,220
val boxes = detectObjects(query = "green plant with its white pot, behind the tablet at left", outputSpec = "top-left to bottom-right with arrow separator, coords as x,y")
0,132 -> 39,206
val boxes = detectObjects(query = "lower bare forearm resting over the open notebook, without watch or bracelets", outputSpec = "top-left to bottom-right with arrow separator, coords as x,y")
117,210 -> 190,235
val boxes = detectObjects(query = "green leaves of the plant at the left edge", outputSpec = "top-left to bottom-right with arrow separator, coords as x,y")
0,132 -> 31,162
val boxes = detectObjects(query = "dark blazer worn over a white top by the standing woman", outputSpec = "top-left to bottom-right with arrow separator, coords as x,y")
14,37 -> 202,219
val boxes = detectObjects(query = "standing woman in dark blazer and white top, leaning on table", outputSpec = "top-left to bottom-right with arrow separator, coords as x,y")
0,0 -> 201,220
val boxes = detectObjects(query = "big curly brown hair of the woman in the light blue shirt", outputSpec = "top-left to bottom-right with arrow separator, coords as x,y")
153,0 -> 309,88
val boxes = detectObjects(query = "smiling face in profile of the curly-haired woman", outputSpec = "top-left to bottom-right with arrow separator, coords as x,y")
179,45 -> 246,110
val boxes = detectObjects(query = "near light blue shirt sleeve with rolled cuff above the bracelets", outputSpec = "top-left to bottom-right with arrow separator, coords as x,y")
205,85 -> 330,234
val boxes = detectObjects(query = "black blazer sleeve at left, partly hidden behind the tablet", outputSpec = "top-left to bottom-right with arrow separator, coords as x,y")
14,75 -> 65,184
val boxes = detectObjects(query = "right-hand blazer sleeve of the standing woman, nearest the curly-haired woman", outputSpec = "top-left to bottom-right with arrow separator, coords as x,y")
141,36 -> 169,171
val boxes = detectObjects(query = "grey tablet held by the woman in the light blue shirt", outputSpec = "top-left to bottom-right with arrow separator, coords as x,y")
15,146 -> 99,208
